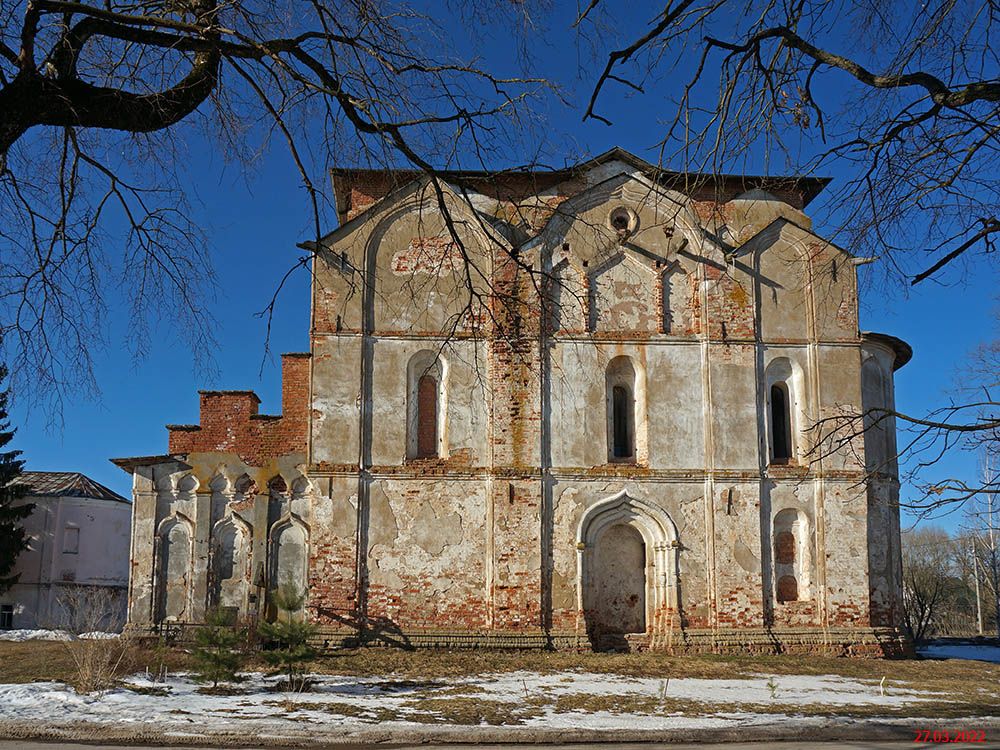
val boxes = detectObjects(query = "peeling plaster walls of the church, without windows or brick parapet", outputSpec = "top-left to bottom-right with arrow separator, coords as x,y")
121,157 -> 912,651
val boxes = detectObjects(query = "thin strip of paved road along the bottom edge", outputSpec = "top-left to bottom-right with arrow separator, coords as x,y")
0,740 -> 1000,750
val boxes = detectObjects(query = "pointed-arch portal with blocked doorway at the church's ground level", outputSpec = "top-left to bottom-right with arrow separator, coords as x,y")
577,491 -> 679,645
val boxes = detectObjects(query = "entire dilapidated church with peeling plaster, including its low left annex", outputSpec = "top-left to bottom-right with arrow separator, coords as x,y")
115,149 -> 911,655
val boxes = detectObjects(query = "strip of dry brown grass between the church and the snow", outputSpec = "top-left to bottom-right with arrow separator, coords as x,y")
0,641 -> 1000,724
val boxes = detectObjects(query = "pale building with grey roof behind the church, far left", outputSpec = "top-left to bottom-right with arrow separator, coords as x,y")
0,471 -> 132,630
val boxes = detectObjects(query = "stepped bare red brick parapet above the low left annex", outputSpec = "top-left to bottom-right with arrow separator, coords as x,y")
167,353 -> 311,465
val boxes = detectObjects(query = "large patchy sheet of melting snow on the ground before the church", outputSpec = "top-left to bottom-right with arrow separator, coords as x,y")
0,671 -> 942,733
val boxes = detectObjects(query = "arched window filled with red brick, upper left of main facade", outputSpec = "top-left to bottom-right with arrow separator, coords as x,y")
406,351 -> 448,458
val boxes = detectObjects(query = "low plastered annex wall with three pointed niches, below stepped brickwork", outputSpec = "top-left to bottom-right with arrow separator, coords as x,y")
129,458 -> 315,627
